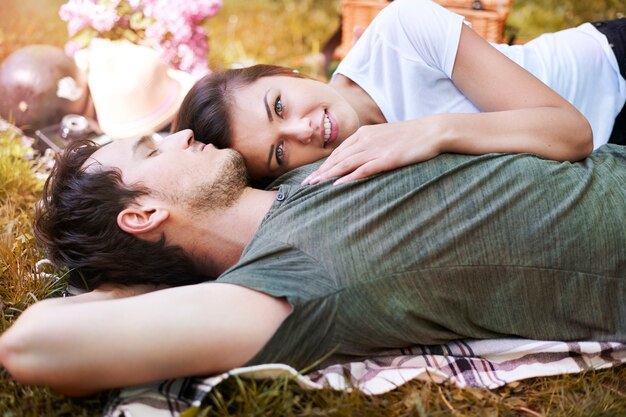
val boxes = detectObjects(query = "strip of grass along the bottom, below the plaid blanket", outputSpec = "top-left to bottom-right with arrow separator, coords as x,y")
190,366 -> 626,417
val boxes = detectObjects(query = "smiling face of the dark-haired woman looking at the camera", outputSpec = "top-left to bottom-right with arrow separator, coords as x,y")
230,76 -> 359,178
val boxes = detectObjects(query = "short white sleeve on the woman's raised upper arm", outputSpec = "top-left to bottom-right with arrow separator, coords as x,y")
381,0 -> 464,77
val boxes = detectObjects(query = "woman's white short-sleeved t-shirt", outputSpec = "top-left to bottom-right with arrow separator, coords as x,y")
335,0 -> 626,149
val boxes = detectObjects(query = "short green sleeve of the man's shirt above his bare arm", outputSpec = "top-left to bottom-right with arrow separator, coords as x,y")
218,242 -> 337,369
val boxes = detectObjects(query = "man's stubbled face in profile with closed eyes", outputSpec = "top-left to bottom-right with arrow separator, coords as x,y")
85,130 -> 247,211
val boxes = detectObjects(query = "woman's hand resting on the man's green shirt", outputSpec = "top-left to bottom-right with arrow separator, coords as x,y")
302,117 -> 441,185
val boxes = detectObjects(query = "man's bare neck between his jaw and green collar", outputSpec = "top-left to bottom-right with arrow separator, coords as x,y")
166,188 -> 276,276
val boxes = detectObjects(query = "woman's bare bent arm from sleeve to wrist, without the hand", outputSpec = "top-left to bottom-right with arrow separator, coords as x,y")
440,25 -> 593,161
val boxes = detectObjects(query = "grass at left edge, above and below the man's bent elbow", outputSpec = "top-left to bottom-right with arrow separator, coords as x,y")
0,131 -> 111,416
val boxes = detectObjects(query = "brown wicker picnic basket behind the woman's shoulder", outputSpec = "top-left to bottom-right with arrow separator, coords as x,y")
335,0 -> 512,59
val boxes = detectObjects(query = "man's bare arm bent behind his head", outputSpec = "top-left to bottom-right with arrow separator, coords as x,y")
0,283 -> 291,395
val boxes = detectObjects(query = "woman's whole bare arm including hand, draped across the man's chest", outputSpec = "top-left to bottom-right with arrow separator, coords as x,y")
306,25 -> 593,184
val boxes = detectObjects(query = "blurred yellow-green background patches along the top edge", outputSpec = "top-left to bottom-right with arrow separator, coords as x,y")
0,0 -> 626,72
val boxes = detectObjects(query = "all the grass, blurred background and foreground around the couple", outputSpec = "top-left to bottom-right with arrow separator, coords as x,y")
0,0 -> 626,417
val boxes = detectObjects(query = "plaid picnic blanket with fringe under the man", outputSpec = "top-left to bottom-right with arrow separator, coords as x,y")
103,339 -> 626,417
